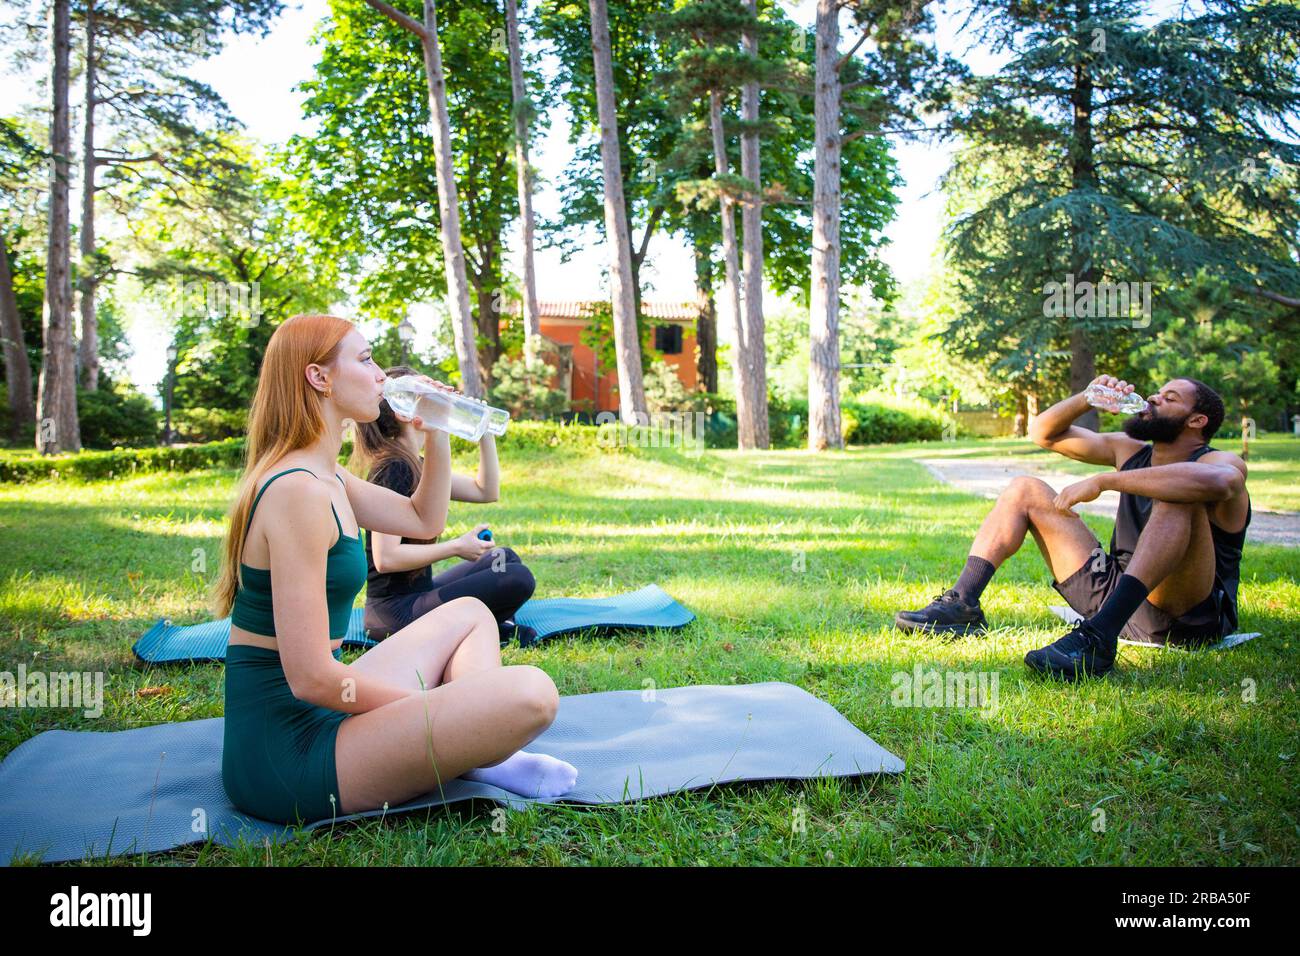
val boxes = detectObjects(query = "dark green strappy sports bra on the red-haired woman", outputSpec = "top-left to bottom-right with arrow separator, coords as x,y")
230,468 -> 367,640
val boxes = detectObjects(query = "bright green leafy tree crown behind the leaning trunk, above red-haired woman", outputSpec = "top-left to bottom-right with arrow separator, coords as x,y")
282,0 -> 535,358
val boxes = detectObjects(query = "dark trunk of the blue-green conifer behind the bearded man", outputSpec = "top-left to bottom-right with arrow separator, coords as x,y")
1070,0 -> 1101,431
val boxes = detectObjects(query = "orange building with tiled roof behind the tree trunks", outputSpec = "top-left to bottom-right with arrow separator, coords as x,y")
512,300 -> 699,411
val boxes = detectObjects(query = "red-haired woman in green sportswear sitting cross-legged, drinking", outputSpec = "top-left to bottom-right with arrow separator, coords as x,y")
216,315 -> 577,823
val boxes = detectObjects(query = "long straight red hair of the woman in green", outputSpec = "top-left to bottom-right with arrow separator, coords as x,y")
213,315 -> 352,618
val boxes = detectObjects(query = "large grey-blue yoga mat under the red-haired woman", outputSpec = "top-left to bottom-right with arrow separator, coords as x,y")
0,682 -> 904,865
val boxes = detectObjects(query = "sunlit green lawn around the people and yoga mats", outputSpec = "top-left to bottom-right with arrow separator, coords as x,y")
0,442 -> 1300,865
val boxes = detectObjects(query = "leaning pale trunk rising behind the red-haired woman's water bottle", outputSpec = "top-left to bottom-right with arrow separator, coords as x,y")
424,0 -> 484,398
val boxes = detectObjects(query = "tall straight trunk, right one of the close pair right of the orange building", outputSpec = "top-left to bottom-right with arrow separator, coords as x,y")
740,0 -> 771,449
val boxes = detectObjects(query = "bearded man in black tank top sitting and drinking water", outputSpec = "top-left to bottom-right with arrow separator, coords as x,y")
894,376 -> 1251,679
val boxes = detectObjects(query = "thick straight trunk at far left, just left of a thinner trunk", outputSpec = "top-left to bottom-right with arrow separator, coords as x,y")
36,0 -> 81,454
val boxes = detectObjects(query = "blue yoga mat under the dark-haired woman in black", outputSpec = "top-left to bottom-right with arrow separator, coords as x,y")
131,584 -> 696,663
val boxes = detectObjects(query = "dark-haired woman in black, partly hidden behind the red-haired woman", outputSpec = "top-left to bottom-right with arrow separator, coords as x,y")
348,365 -> 537,646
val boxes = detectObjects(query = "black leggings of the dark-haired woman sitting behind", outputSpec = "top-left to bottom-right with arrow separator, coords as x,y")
365,548 -> 537,641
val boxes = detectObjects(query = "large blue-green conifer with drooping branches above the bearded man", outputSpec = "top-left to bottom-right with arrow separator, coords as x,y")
950,0 -> 1300,425
